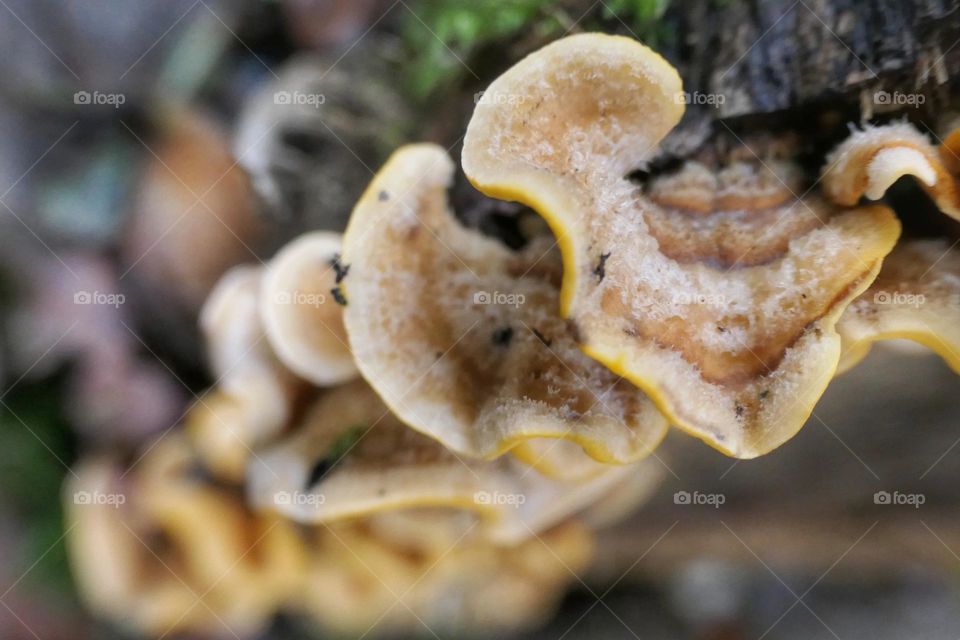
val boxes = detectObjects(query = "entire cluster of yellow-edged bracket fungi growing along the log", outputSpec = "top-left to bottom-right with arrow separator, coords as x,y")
65,35 -> 960,633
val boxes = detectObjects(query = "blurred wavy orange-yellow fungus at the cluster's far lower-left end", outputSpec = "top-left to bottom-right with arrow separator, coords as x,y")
66,434 -> 305,635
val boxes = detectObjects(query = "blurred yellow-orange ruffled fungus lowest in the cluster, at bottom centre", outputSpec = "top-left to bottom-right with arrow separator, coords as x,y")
297,521 -> 593,635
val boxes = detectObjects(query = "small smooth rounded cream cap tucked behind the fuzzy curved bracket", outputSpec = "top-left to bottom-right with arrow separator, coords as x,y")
260,232 -> 357,387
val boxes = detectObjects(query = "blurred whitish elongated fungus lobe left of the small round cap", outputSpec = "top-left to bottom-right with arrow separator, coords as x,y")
187,266 -> 299,480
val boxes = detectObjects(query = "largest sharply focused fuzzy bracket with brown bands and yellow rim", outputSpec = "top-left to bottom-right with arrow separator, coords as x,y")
464,34 -> 900,458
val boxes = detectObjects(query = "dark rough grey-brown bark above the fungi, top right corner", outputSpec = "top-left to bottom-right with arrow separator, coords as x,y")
659,0 -> 960,154
